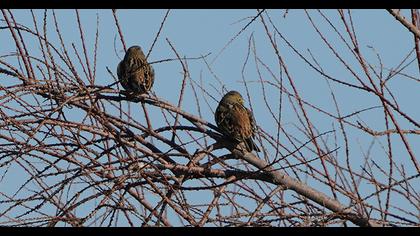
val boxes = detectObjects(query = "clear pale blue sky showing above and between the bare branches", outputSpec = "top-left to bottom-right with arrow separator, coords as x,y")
0,9 -> 420,227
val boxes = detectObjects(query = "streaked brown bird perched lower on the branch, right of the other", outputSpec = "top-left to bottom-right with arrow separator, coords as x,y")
214,91 -> 260,152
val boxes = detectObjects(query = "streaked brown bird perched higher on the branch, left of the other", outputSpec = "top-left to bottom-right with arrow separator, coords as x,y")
117,46 -> 155,95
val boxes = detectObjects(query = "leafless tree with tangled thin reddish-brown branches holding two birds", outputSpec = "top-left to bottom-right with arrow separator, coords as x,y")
0,10 -> 420,226
